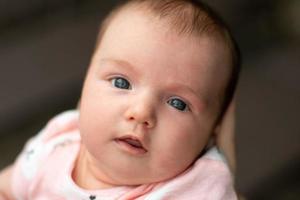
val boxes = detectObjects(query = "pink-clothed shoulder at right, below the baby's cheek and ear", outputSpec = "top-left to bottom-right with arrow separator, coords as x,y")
146,148 -> 237,200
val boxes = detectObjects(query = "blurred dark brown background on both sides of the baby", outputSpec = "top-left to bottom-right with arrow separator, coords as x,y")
0,0 -> 300,200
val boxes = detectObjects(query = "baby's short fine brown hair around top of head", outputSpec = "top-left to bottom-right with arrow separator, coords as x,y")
96,0 -> 240,123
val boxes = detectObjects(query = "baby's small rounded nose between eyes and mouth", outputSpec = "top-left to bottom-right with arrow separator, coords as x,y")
124,94 -> 156,128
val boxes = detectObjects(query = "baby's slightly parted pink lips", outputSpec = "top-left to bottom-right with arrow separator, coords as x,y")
114,135 -> 148,155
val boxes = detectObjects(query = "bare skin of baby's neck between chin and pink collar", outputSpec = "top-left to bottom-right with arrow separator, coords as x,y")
72,145 -> 116,190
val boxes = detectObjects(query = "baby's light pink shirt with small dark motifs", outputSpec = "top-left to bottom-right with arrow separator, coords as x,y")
12,111 -> 237,200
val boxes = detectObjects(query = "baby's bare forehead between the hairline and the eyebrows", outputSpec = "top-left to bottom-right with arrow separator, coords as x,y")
95,9 -> 229,104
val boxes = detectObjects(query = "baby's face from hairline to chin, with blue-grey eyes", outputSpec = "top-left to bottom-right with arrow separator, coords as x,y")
80,7 -> 228,185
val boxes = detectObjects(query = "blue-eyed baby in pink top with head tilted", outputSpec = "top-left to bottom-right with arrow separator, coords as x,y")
0,0 -> 239,200
